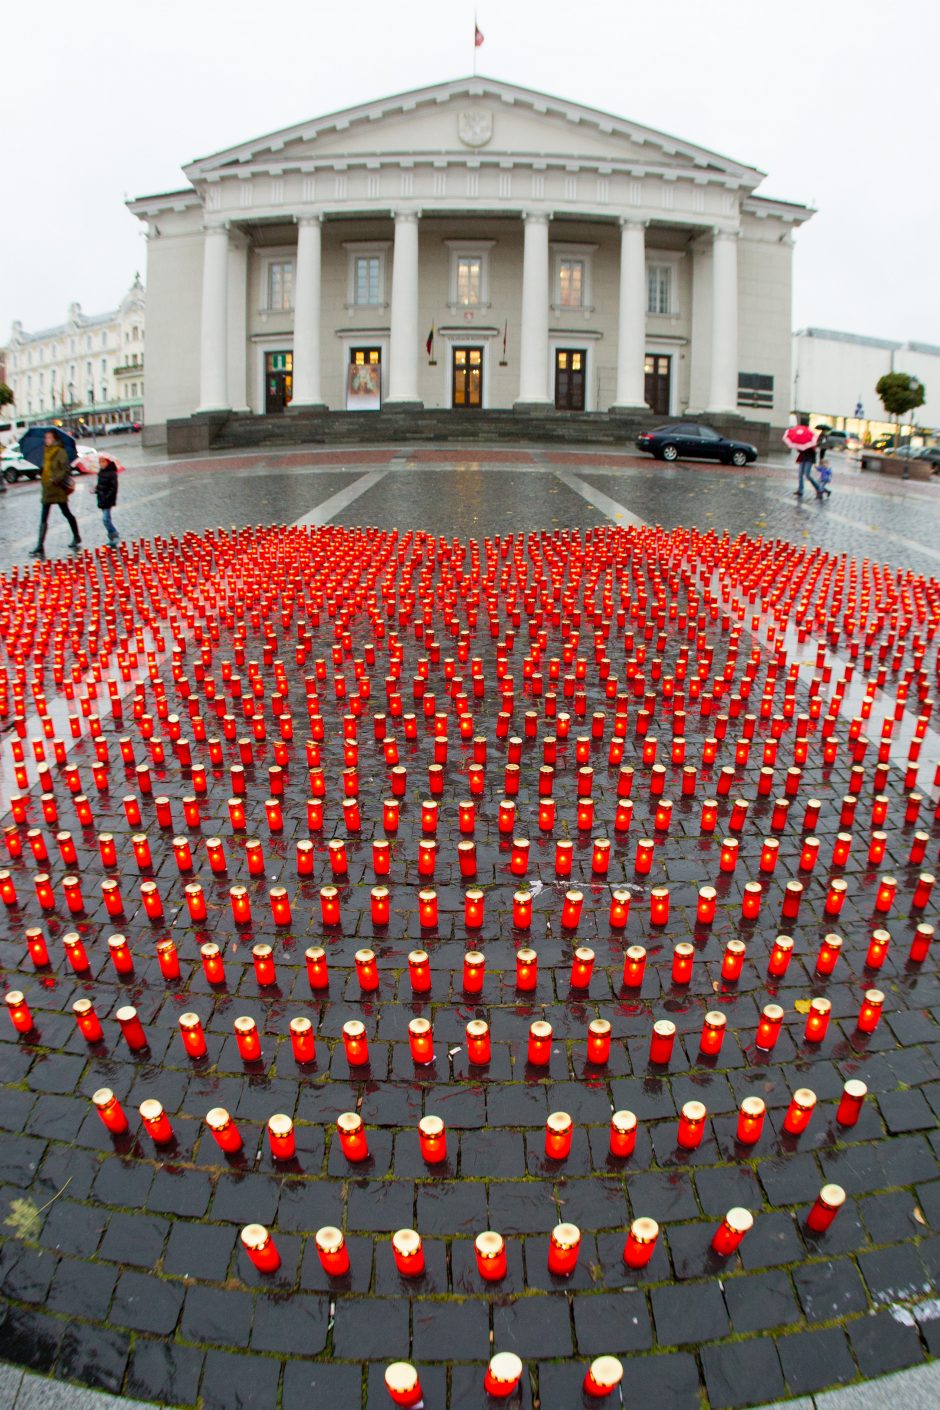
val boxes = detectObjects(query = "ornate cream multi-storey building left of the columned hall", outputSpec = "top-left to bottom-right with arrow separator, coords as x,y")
6,275 -> 145,430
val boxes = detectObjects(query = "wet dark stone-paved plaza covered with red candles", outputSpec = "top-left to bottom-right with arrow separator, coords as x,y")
0,444 -> 940,1410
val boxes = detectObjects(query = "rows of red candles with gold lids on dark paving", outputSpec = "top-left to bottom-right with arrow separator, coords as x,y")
0,527 -> 940,1406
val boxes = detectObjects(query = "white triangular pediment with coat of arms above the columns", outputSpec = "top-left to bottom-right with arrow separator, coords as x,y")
186,78 -> 762,188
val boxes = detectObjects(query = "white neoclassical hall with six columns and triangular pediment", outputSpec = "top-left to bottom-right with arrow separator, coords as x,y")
130,78 -> 810,440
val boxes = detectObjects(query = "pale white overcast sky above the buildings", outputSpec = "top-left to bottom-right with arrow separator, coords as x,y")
0,0 -> 940,344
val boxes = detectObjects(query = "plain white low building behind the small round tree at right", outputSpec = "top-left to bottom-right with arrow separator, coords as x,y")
793,329 -> 940,437
